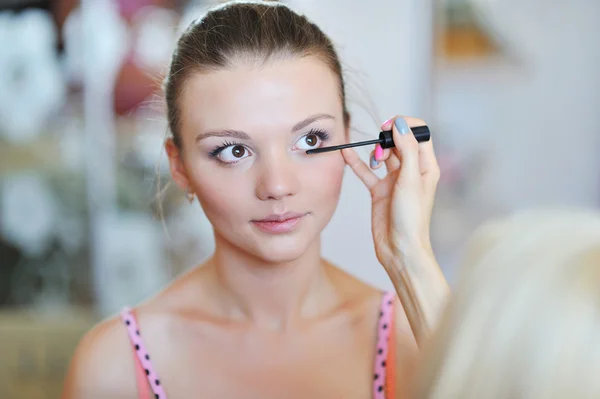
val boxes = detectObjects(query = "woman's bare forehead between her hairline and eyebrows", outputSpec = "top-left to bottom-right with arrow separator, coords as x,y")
180,57 -> 342,129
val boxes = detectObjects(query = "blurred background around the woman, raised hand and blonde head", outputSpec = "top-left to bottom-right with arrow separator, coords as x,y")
0,0 -> 600,399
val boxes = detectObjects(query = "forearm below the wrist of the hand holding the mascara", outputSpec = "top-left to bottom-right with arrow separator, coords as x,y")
386,249 -> 450,346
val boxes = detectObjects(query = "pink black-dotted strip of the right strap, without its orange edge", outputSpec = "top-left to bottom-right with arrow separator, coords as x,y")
373,292 -> 395,399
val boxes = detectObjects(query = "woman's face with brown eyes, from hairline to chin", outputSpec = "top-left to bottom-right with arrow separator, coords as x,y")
168,57 -> 347,262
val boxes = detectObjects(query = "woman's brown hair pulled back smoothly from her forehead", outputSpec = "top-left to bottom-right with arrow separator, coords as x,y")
164,1 -> 349,148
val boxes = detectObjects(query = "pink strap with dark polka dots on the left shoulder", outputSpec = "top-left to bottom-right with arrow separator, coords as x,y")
121,308 -> 167,399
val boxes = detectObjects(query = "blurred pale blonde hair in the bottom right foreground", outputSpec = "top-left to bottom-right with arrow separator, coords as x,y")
416,210 -> 600,399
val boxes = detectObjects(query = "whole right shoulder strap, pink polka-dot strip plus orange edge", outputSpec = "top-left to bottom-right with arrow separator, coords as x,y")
373,292 -> 395,399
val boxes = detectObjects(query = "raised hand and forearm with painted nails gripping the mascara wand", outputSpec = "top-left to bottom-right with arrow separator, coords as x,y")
341,116 -> 449,342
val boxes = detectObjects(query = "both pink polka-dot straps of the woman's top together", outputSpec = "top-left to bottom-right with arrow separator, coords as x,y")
121,292 -> 395,399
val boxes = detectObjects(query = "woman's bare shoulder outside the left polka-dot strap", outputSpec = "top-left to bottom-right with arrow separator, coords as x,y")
62,316 -> 137,399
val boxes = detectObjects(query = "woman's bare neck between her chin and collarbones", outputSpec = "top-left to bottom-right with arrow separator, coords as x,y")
207,237 -> 337,330
